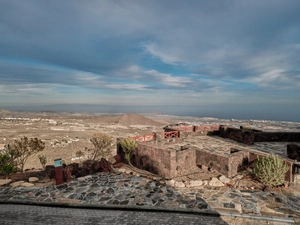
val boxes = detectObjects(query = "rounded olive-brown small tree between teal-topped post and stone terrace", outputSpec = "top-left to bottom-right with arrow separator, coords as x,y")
85,133 -> 113,160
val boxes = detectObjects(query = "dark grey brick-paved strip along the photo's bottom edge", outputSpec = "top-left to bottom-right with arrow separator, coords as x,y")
0,204 -> 228,225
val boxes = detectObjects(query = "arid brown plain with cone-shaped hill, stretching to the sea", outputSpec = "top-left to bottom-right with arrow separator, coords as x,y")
0,110 -> 300,169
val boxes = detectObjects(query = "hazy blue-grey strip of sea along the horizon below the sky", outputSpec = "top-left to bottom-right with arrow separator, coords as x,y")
0,104 -> 300,122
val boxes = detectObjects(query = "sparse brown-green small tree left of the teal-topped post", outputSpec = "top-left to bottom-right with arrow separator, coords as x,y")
11,137 -> 45,172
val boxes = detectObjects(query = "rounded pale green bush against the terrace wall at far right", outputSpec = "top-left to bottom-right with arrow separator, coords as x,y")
252,155 -> 289,187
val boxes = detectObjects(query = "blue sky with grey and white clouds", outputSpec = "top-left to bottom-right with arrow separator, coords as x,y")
0,0 -> 300,122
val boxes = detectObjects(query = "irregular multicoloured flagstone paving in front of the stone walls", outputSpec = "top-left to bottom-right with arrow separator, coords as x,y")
0,172 -> 300,221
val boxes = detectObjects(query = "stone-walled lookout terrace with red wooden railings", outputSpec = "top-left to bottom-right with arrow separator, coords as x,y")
117,124 -> 300,182
